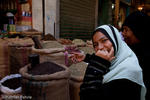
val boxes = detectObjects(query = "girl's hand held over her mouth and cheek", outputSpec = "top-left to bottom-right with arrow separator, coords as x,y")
95,47 -> 115,61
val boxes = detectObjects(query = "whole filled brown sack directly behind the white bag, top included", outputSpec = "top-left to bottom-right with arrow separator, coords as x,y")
8,39 -> 33,74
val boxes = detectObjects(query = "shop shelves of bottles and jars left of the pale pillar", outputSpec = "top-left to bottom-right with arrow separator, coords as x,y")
0,0 -> 32,37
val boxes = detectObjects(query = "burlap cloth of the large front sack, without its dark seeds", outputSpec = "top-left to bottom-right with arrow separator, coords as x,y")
20,62 -> 70,100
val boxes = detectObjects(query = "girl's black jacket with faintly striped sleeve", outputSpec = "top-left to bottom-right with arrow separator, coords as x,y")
79,54 -> 141,100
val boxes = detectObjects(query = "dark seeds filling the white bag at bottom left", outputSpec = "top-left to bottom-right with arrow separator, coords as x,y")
2,77 -> 21,89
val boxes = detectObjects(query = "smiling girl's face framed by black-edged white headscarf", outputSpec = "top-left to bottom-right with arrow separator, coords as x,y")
93,32 -> 114,54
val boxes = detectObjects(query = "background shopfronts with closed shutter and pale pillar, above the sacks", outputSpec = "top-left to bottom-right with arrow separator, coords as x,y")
0,0 -> 150,40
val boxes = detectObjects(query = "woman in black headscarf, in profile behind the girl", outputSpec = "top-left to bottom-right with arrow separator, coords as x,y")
122,11 -> 150,100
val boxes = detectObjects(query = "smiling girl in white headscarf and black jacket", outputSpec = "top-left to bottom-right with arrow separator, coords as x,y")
71,25 -> 146,100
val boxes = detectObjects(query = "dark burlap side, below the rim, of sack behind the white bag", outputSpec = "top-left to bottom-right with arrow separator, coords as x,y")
9,45 -> 32,74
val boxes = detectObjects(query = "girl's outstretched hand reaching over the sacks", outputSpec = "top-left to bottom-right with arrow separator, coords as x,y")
69,52 -> 85,64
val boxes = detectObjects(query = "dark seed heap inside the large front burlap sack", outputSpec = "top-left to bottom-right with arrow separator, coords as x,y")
28,62 -> 65,75
